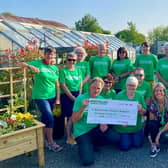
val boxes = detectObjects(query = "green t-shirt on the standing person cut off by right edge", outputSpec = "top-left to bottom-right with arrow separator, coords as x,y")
156,58 -> 168,89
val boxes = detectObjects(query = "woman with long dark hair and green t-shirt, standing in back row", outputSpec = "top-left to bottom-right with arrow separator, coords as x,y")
111,47 -> 133,93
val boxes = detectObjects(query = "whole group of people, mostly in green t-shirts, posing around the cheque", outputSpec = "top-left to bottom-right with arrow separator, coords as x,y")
20,42 -> 168,166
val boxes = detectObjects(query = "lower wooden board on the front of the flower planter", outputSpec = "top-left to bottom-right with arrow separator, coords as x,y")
0,136 -> 37,161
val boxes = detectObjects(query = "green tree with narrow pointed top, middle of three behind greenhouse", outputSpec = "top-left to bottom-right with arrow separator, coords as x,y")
115,22 -> 145,44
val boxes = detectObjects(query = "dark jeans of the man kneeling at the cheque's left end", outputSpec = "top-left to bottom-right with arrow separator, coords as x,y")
76,127 -> 119,166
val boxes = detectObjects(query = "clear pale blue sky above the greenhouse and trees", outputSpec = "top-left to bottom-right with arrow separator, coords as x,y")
0,0 -> 168,35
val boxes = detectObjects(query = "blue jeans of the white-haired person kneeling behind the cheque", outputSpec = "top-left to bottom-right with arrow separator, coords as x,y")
120,129 -> 144,151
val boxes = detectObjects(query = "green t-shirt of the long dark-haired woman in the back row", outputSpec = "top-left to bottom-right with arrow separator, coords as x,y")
111,58 -> 133,89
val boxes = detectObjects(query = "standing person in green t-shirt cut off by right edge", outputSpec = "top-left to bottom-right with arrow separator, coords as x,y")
156,43 -> 168,90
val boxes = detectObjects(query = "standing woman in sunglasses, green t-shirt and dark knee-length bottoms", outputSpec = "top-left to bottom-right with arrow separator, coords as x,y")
59,53 -> 83,144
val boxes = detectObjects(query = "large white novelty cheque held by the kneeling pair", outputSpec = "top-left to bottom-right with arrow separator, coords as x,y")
87,99 -> 138,126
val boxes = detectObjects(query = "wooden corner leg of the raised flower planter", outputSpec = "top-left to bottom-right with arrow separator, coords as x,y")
36,128 -> 45,167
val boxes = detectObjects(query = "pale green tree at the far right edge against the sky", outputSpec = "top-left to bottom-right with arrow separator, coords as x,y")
148,26 -> 168,44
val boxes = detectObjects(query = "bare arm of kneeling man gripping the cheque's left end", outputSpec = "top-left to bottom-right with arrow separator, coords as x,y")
72,100 -> 89,123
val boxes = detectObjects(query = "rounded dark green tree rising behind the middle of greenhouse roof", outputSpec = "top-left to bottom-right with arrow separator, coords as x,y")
75,14 -> 111,34
